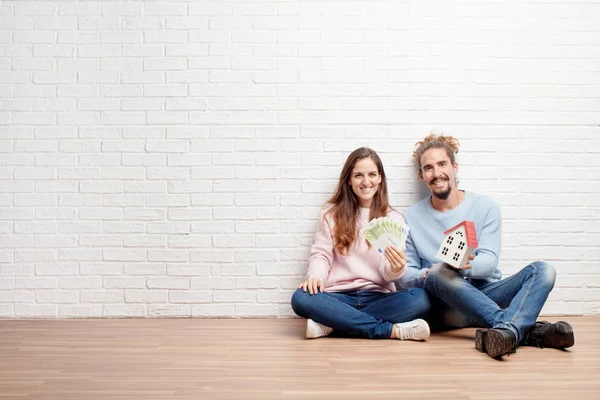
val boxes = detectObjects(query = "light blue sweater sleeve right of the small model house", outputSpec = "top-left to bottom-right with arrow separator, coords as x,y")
462,198 -> 502,279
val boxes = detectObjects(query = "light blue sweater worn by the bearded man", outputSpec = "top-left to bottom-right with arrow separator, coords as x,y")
396,191 -> 502,288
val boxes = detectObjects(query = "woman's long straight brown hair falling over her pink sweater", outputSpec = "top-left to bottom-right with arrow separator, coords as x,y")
327,147 -> 390,255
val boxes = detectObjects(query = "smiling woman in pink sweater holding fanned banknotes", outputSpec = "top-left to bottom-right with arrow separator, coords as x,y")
292,147 -> 430,340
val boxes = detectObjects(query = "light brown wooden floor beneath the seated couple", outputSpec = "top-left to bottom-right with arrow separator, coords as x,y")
0,316 -> 600,400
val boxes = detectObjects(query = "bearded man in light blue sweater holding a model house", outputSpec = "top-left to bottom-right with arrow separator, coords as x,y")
396,134 -> 574,357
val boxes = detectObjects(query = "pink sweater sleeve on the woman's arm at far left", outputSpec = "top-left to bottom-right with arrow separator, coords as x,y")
306,210 -> 333,282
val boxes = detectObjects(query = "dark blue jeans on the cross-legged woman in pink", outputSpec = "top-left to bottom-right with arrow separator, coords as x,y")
292,288 -> 431,339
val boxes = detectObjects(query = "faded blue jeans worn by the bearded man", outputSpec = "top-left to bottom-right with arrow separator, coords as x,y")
424,261 -> 556,343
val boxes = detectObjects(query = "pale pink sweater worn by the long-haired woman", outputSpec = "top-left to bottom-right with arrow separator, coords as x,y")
306,208 -> 406,292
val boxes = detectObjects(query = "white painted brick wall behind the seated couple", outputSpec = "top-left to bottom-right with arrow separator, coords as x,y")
0,0 -> 600,317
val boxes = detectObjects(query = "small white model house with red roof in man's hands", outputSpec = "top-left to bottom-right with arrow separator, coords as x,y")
436,221 -> 478,268
